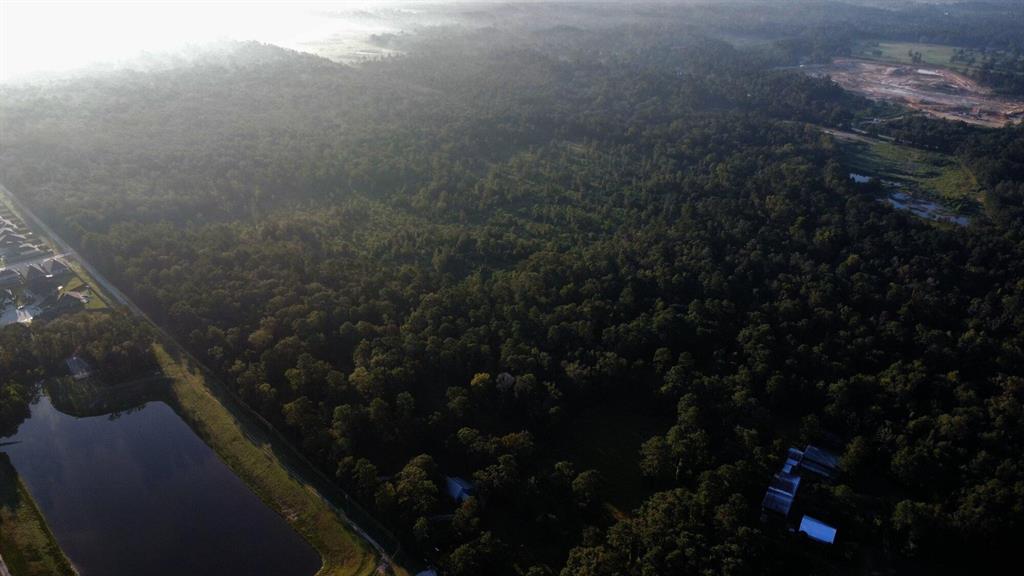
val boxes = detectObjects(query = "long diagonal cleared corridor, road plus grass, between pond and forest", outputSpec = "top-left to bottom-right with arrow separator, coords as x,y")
0,184 -> 408,576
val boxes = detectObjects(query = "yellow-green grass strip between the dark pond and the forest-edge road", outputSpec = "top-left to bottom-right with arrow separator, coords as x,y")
154,343 -> 377,576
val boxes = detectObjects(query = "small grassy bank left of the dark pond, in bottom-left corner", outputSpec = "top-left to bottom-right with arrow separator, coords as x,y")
0,452 -> 76,576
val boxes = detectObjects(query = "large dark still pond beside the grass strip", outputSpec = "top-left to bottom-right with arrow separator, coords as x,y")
3,397 -> 321,576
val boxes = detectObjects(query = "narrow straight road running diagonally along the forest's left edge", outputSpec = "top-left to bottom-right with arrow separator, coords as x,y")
0,183 -> 407,576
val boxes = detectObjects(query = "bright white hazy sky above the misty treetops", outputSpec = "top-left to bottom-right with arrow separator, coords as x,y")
0,0 -> 419,81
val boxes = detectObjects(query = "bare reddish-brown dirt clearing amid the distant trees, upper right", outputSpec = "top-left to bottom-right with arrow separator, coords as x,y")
811,58 -> 1024,127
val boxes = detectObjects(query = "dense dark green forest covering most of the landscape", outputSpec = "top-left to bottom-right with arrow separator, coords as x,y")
0,1 -> 1024,576
